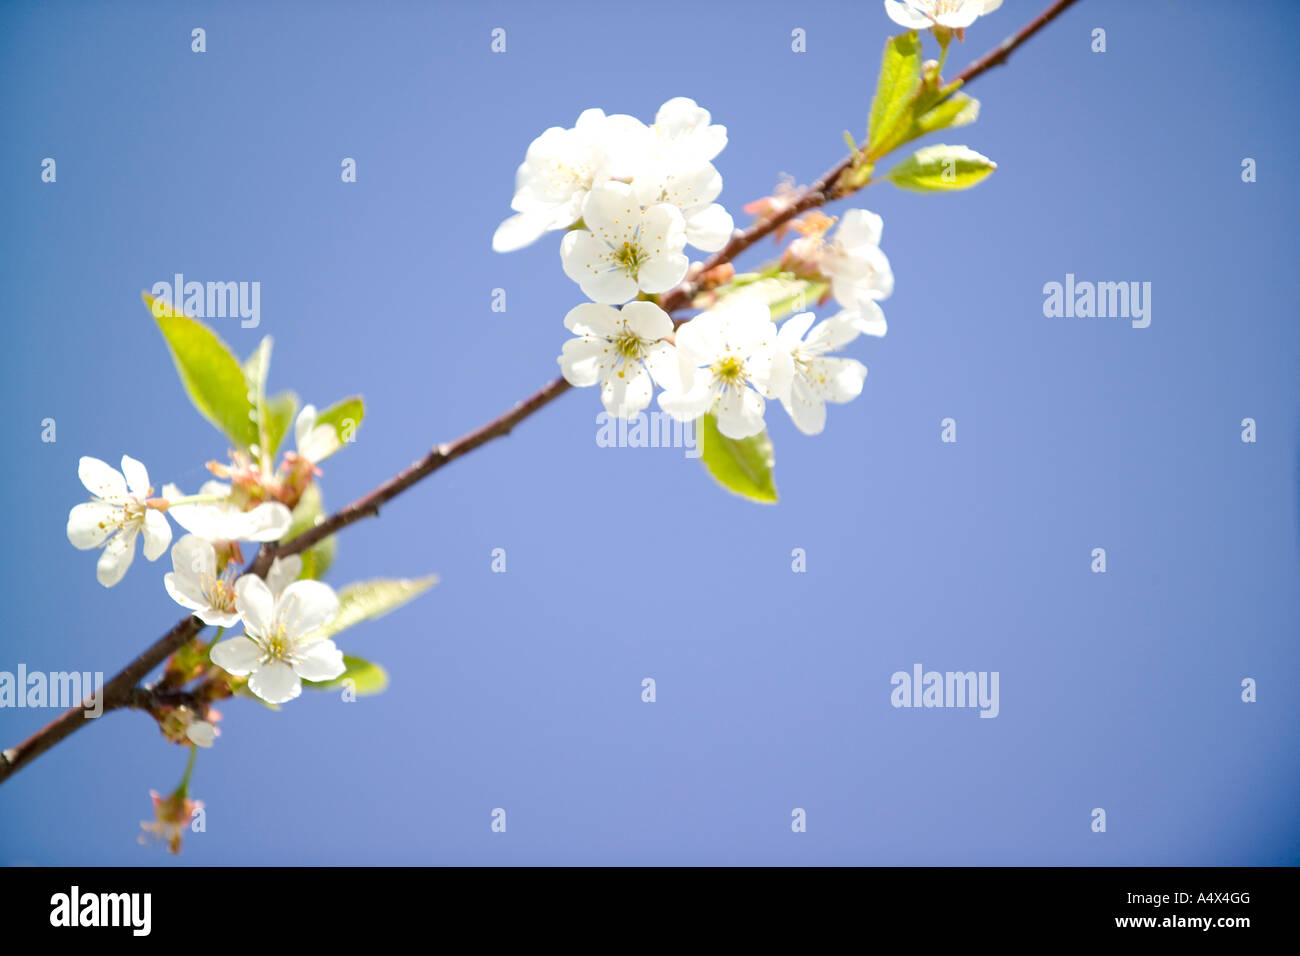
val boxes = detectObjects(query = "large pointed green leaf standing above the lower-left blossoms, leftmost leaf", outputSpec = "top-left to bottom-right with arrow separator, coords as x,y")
140,293 -> 257,450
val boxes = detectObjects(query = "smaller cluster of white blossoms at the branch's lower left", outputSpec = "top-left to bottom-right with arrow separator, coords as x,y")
68,406 -> 345,712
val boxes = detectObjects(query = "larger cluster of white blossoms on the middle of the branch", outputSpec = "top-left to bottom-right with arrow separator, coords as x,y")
493,98 -> 893,438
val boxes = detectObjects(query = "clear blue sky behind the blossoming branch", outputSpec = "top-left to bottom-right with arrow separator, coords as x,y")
0,0 -> 1300,864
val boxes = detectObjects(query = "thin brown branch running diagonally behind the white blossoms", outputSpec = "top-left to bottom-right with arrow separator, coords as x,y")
0,0 -> 1076,783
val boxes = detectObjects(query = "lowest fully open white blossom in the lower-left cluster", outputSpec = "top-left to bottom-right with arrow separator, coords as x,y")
211,575 -> 346,704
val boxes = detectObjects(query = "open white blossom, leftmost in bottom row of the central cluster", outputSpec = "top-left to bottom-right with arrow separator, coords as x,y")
558,302 -> 680,418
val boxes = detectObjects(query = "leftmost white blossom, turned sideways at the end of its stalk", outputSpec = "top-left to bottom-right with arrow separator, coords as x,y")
68,455 -> 172,588
